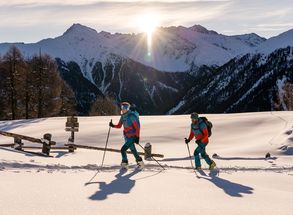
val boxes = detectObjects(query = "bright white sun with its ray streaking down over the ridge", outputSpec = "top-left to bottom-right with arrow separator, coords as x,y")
139,13 -> 159,56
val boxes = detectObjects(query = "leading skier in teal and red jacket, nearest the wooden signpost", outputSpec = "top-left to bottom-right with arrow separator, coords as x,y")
109,102 -> 143,167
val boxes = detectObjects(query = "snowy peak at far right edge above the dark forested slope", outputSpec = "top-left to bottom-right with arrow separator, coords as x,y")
256,29 -> 293,54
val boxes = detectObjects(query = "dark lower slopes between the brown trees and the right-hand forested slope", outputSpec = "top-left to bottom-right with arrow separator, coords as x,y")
57,55 -> 194,114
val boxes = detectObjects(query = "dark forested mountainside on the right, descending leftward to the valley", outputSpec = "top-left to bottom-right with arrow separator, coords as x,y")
174,47 -> 293,114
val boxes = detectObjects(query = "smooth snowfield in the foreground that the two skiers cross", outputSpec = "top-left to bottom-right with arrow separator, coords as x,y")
0,112 -> 293,215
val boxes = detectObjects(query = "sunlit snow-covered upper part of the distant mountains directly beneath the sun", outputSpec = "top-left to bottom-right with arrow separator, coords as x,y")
0,24 -> 263,72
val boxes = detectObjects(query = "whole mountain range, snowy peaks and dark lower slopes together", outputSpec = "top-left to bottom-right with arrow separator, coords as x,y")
0,24 -> 293,114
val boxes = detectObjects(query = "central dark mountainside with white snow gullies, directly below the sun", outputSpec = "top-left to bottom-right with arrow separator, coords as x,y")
92,56 -> 194,114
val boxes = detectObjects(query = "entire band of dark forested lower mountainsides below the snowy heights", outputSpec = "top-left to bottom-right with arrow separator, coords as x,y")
57,47 -> 293,114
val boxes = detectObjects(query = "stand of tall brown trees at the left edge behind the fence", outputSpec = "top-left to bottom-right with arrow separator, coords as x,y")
0,47 -> 76,119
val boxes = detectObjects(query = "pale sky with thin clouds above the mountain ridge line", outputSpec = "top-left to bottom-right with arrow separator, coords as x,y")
0,0 -> 293,43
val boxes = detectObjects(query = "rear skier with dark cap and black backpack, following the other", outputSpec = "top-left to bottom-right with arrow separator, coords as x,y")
185,113 -> 216,170
